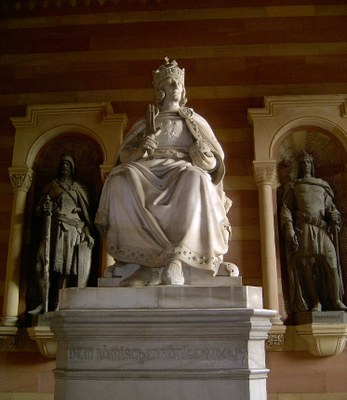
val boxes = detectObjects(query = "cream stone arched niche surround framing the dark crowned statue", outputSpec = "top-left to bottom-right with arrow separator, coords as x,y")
248,95 -> 347,348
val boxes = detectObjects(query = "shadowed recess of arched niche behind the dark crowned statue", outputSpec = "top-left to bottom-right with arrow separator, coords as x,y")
273,125 -> 347,324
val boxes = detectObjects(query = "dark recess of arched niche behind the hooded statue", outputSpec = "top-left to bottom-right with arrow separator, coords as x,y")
24,131 -> 104,318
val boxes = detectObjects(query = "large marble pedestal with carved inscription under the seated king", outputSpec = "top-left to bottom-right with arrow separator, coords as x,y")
51,286 -> 275,400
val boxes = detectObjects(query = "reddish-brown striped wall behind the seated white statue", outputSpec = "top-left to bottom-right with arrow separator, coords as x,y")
0,0 -> 347,393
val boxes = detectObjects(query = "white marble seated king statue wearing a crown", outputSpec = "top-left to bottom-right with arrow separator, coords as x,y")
95,58 -> 231,286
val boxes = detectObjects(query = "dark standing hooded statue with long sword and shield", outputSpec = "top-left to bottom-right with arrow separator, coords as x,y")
30,155 -> 94,314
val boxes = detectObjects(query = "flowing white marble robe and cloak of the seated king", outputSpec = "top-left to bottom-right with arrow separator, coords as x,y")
95,108 -> 231,274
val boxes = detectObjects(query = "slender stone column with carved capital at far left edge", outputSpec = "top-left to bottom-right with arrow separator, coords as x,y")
0,167 -> 33,331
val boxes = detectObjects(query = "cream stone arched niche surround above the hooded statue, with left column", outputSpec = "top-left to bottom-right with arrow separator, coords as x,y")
0,103 -> 127,335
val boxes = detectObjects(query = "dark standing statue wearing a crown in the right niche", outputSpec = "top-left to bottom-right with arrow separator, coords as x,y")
280,151 -> 347,313
